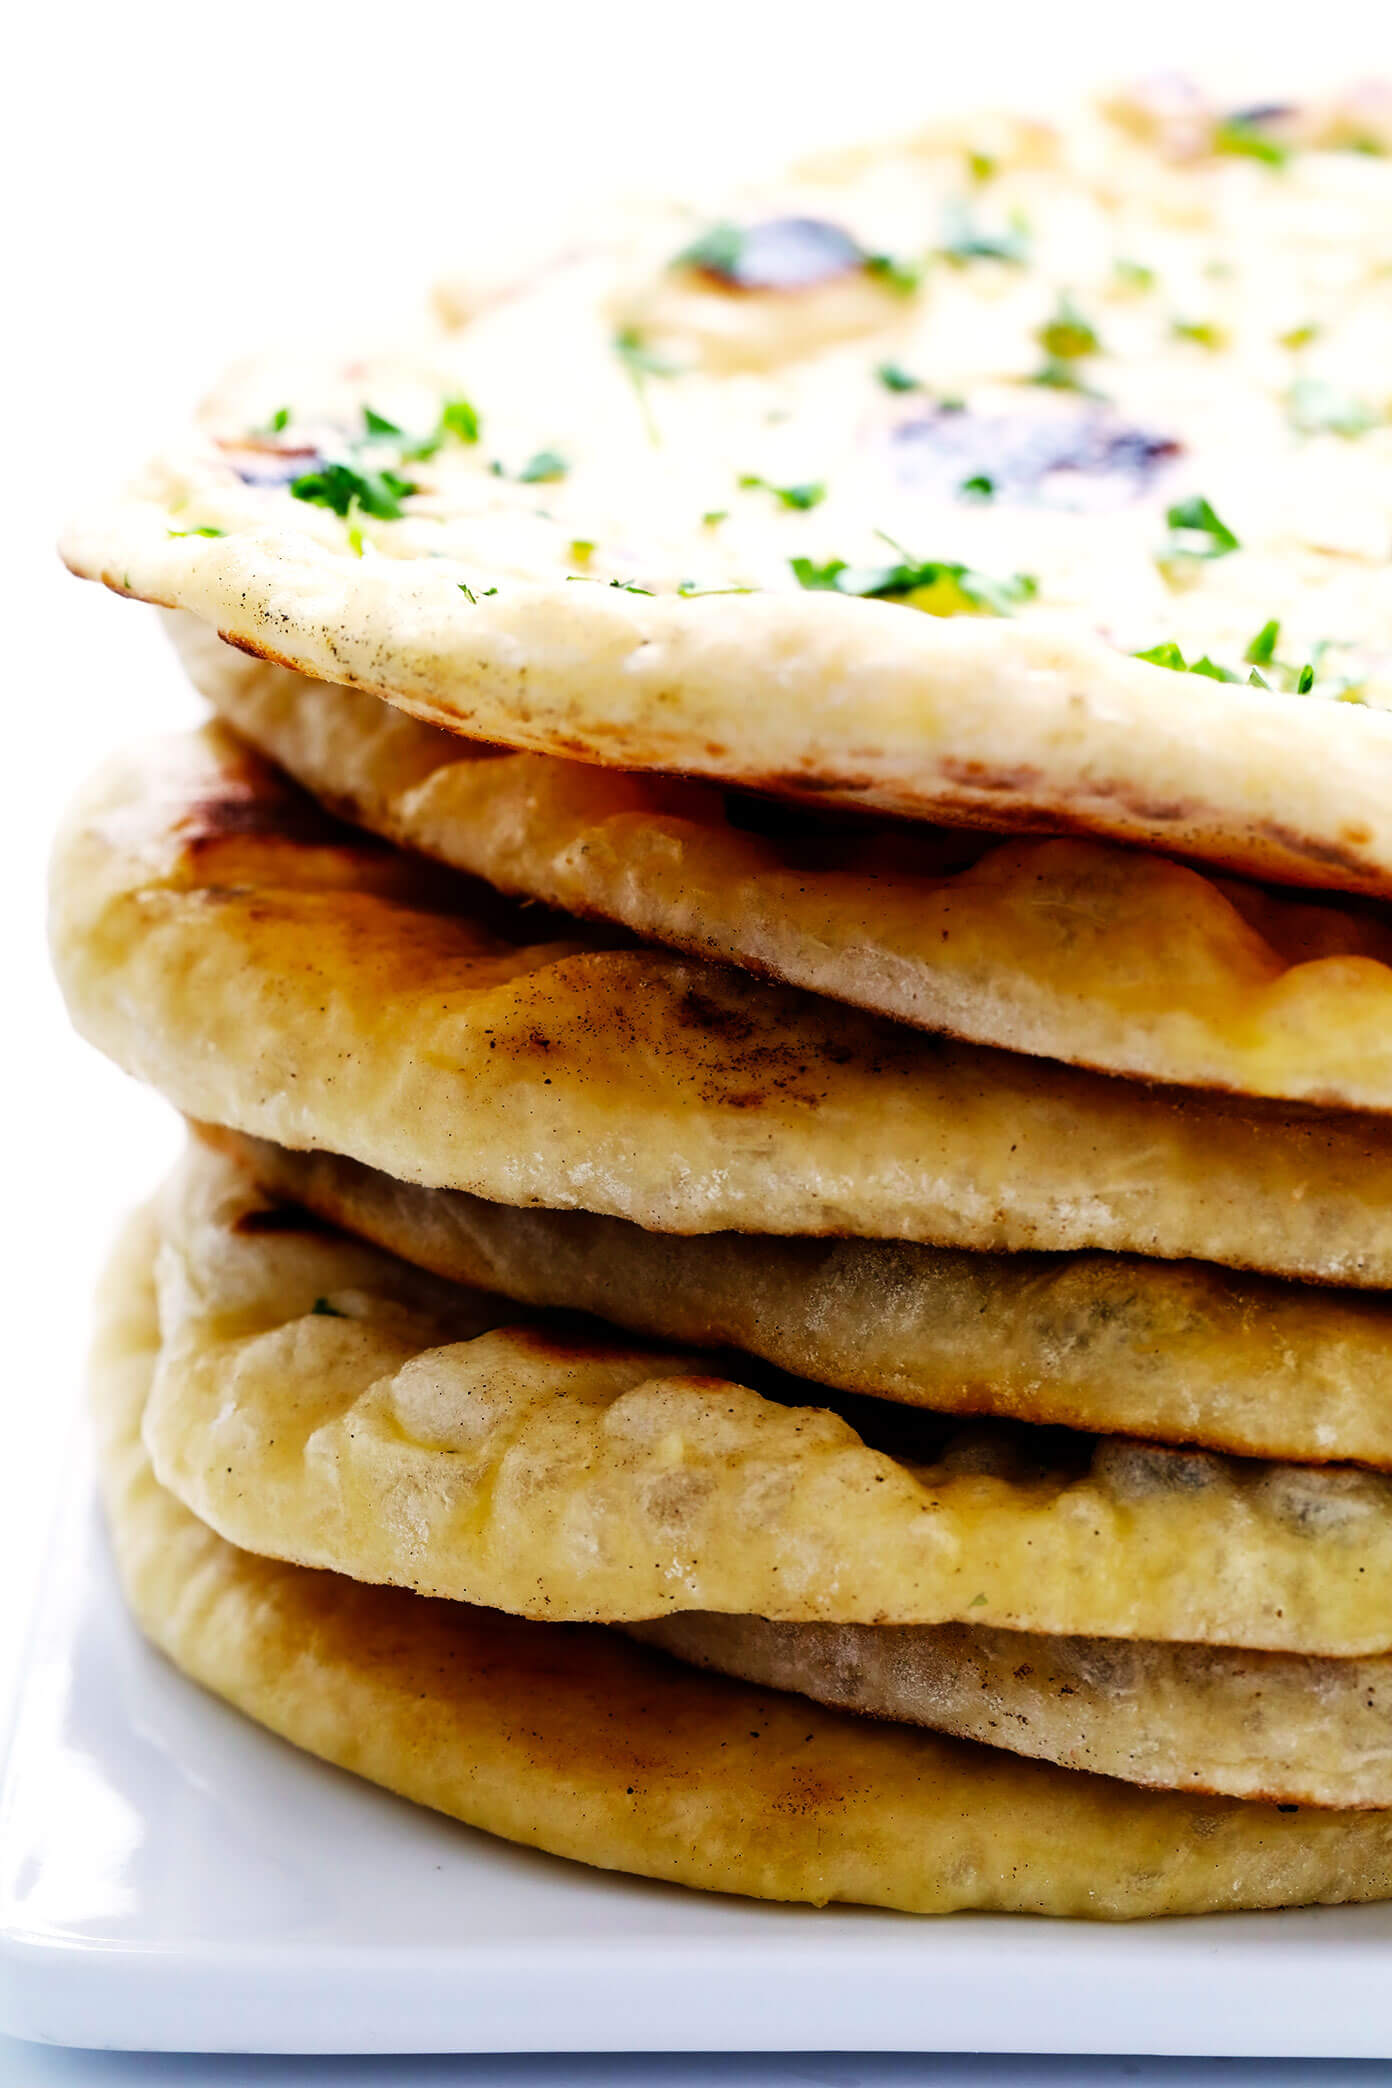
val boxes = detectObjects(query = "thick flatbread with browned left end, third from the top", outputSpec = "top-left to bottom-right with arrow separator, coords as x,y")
52,731 -> 1392,1286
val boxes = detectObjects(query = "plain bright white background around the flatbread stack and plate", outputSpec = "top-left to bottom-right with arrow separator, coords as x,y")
0,0 -> 1392,2082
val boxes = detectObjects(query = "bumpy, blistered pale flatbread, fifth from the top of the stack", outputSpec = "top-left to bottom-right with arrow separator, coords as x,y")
144,1150 -> 1392,1654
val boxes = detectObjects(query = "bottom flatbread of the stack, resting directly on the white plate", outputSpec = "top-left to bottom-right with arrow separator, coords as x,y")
92,1194 -> 1392,1919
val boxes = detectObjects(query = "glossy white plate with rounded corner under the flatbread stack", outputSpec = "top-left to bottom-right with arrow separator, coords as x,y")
0,1487 -> 1392,2057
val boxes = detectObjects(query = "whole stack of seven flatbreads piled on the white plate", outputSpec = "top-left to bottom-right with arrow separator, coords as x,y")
54,81 -> 1392,1917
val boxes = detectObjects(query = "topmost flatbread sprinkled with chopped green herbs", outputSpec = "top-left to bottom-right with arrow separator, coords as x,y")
63,94 -> 1392,894
